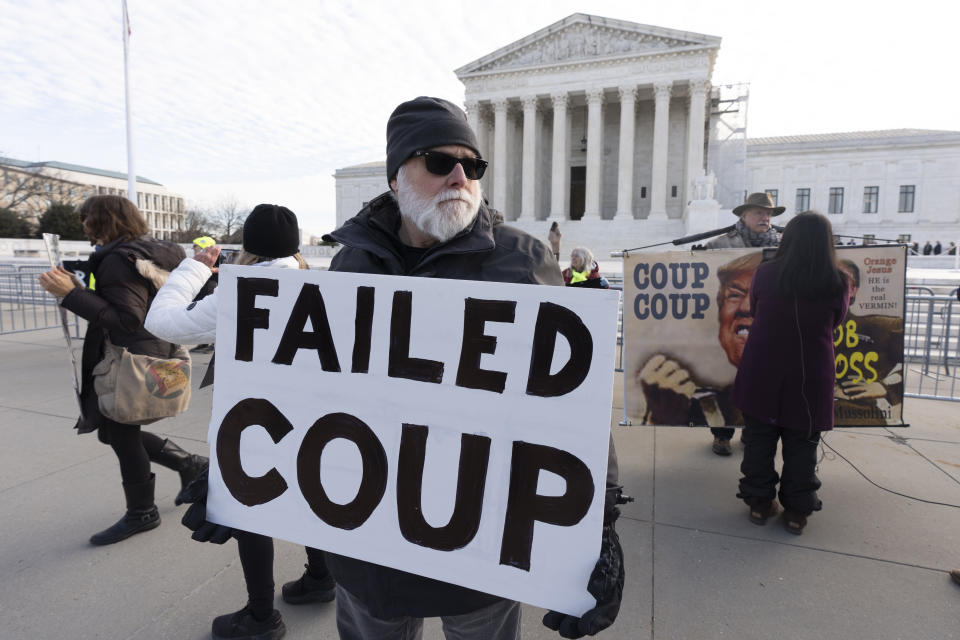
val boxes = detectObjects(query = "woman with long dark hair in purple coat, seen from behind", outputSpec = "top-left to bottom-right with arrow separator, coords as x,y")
733,211 -> 848,535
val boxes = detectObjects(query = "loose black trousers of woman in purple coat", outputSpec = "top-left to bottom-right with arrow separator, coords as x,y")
737,416 -> 821,516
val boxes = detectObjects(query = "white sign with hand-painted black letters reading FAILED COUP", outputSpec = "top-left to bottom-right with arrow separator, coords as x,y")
207,266 -> 619,615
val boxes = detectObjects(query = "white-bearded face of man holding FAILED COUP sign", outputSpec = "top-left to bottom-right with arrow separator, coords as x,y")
391,145 -> 480,242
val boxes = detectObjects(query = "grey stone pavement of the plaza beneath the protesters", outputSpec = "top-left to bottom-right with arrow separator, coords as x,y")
0,330 -> 960,640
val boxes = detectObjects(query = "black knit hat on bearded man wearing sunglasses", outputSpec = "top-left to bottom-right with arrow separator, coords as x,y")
387,96 -> 480,181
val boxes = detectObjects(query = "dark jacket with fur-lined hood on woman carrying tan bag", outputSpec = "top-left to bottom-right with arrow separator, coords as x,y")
60,237 -> 186,433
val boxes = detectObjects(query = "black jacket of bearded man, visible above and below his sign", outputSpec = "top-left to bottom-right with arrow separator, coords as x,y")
324,192 -> 563,619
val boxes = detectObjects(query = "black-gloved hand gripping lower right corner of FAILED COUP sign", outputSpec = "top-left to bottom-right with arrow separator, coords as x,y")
543,486 -> 633,638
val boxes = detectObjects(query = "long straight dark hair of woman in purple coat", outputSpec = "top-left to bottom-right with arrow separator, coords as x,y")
773,211 -> 847,299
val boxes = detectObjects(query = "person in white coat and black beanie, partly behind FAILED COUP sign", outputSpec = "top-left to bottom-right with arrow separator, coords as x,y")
146,204 -> 336,640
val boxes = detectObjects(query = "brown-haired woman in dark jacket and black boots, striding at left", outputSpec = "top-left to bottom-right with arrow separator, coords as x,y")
40,196 -> 207,545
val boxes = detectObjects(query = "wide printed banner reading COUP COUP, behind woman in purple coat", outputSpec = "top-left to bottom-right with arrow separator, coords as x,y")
623,246 -> 906,427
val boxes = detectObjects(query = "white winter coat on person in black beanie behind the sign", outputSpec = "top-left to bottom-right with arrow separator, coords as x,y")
143,256 -> 300,344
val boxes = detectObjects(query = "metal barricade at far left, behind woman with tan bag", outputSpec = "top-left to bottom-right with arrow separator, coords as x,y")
0,264 -> 80,338
